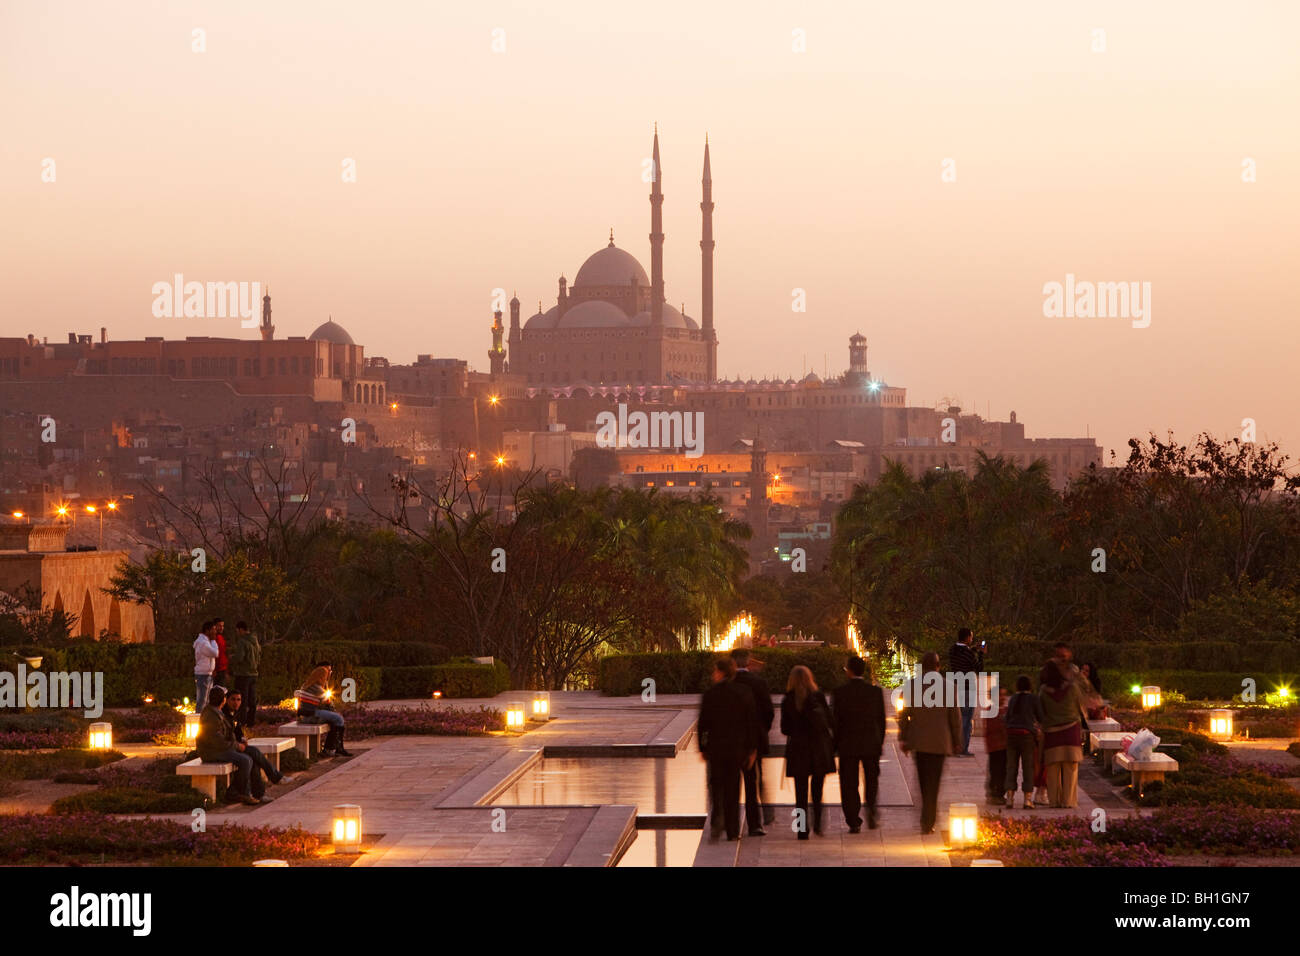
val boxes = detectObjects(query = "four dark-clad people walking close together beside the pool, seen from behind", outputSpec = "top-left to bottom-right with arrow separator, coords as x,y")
697,648 -> 885,840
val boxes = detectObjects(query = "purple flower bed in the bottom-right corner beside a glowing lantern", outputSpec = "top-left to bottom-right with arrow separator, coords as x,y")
975,808 -> 1300,866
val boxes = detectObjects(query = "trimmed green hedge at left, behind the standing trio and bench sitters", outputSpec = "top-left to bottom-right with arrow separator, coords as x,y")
0,641 -> 510,708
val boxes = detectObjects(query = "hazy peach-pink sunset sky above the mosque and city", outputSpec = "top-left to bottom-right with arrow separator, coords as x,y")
0,0 -> 1300,457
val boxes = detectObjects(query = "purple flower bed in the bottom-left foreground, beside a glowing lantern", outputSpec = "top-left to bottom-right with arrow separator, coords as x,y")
0,813 -> 320,866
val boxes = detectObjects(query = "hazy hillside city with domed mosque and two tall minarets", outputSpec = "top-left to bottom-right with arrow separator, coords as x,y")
0,134 -> 1101,640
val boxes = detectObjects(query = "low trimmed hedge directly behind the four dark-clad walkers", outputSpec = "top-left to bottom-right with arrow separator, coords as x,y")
597,648 -> 849,697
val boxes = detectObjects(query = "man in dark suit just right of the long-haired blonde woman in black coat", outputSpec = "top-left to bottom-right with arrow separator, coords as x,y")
831,657 -> 885,834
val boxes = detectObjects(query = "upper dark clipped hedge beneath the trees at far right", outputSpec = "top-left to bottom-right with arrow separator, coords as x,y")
988,639 -> 1300,684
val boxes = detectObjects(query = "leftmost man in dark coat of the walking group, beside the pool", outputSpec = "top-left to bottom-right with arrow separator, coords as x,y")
696,657 -> 759,840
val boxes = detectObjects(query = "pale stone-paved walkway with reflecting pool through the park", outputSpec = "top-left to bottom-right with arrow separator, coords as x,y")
175,692 -> 1123,866
